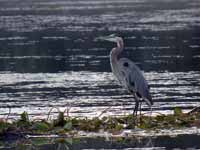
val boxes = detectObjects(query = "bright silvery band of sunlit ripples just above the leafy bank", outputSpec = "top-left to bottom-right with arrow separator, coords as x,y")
0,71 -> 200,116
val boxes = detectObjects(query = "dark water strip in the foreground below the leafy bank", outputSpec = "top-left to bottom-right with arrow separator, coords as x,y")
1,134 -> 200,150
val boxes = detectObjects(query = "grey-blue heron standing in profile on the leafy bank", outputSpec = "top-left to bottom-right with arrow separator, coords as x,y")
101,35 -> 153,116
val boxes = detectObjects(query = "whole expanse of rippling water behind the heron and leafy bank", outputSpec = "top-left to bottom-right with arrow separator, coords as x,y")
0,0 -> 200,119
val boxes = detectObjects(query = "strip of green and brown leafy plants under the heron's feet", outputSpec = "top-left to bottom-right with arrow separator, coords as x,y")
0,108 -> 200,136
